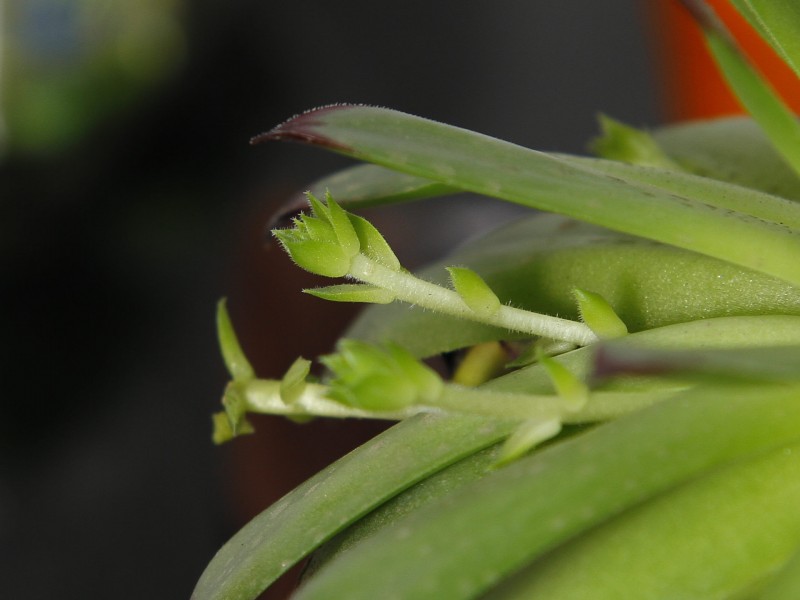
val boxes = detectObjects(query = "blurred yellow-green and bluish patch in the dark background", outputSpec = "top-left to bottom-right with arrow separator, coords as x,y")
0,0 -> 184,155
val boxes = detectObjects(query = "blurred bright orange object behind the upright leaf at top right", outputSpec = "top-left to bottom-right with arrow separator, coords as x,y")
650,0 -> 800,121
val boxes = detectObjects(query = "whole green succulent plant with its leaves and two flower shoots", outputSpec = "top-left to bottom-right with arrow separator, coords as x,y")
193,1 -> 800,600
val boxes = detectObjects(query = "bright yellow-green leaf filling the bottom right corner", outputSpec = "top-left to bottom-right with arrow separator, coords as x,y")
484,444 -> 800,600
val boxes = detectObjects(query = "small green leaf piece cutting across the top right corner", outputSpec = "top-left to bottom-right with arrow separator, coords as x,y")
732,0 -> 800,76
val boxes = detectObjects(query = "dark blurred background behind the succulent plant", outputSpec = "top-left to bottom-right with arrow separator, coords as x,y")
0,0 -> 764,600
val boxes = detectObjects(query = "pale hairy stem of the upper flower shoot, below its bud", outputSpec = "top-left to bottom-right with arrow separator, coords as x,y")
350,254 -> 597,346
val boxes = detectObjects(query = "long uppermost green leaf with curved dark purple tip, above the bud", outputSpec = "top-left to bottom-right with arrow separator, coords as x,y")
255,106 -> 800,285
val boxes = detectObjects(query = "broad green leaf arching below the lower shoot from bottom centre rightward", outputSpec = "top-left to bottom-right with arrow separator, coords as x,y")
295,386 -> 800,600
